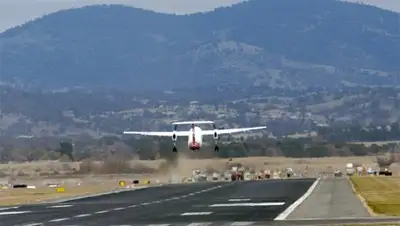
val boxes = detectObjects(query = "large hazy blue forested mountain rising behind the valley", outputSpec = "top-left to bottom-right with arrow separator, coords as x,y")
0,0 -> 400,90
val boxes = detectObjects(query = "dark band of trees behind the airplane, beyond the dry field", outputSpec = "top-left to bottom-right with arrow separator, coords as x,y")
0,136 -> 393,162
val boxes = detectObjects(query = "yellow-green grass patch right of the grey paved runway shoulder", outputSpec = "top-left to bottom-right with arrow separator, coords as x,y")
350,176 -> 400,216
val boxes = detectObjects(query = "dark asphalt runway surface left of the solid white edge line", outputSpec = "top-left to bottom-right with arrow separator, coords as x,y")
0,179 -> 315,226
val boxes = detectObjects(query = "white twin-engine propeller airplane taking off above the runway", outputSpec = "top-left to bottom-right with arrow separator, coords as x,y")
124,121 -> 267,152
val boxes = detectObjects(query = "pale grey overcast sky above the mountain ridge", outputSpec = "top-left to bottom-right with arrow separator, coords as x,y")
0,0 -> 400,32
